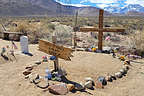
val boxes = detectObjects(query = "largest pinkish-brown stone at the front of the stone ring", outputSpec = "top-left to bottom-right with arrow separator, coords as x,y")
48,83 -> 68,95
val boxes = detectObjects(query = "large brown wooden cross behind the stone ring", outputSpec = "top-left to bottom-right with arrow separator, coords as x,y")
80,9 -> 125,50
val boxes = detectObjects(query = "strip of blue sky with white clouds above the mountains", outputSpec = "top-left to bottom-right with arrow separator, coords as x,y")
56,0 -> 144,8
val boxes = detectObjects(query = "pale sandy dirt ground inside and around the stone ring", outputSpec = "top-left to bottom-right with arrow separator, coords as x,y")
0,39 -> 144,96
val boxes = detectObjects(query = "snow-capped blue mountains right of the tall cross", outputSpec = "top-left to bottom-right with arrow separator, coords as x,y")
104,4 -> 144,14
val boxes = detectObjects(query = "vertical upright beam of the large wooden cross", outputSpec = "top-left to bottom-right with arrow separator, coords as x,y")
98,9 -> 104,50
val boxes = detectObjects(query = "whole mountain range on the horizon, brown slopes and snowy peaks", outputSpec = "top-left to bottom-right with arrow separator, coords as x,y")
0,0 -> 144,16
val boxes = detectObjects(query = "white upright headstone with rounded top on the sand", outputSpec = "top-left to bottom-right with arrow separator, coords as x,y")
20,36 -> 29,53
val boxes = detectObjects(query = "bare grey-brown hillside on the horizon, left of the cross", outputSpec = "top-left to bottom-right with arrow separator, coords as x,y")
0,0 -> 109,16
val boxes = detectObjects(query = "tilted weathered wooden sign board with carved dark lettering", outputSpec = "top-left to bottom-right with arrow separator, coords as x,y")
39,40 -> 72,61
